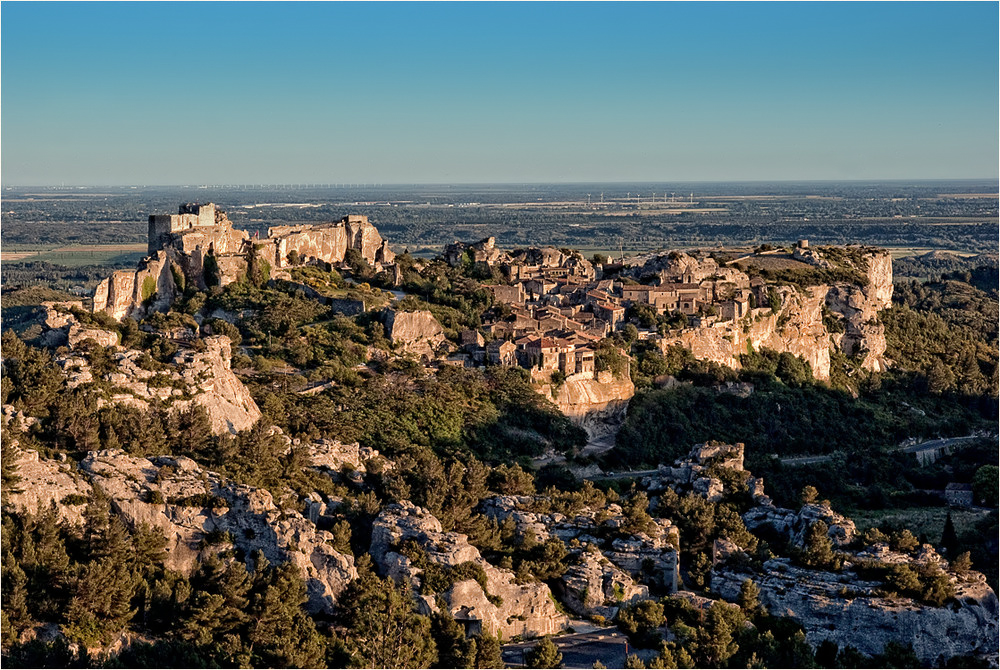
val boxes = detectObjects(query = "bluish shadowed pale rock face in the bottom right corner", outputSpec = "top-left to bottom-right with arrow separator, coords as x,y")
712,559 -> 998,664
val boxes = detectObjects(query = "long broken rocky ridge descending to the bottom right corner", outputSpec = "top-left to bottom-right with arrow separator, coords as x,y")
643,444 -> 998,663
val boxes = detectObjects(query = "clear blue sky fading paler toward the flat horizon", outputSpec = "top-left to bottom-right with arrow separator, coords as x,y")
0,2 -> 1000,185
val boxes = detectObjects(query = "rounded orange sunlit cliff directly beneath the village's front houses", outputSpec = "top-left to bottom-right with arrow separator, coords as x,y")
550,377 -> 635,438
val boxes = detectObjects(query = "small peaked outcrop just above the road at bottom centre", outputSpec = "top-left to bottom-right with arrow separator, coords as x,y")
557,551 -> 649,621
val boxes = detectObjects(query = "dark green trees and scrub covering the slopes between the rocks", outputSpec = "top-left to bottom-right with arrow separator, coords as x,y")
0,239 -> 997,668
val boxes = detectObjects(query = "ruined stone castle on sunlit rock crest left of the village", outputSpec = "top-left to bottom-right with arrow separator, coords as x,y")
93,203 -> 395,319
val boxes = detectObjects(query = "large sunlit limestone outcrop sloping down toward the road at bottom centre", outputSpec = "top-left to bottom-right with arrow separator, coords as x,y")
371,501 -> 568,637
